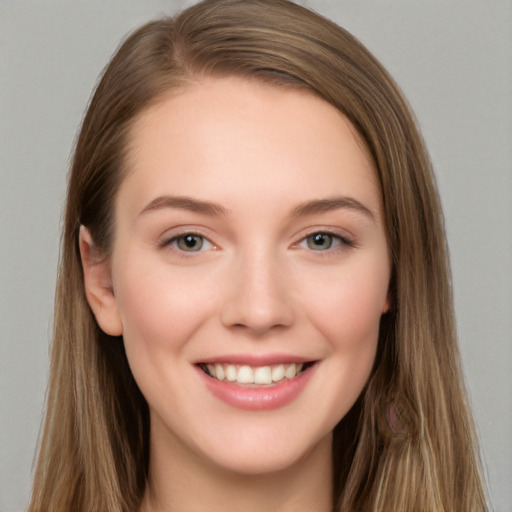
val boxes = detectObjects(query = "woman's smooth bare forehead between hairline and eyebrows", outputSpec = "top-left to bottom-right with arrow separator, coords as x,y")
120,77 -> 380,218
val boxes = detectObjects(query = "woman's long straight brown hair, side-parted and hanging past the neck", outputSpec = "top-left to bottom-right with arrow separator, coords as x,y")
29,0 -> 487,512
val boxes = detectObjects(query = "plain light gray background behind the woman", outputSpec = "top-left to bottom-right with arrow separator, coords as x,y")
0,0 -> 512,512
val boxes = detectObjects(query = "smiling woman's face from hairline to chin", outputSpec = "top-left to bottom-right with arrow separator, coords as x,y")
84,78 -> 390,473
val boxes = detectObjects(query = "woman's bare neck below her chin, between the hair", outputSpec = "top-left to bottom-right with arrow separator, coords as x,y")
141,430 -> 332,512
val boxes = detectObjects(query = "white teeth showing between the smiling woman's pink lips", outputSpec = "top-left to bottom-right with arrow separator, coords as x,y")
198,361 -> 315,386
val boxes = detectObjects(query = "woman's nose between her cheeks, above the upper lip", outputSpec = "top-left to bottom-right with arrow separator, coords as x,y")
221,248 -> 295,336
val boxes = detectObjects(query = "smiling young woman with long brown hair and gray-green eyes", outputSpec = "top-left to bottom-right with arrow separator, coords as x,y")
29,0 -> 486,511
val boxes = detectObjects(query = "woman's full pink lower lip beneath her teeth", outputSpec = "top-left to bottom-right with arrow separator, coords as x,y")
197,364 -> 317,411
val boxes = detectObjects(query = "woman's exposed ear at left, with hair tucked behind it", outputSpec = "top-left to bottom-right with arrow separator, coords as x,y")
79,226 -> 123,336
